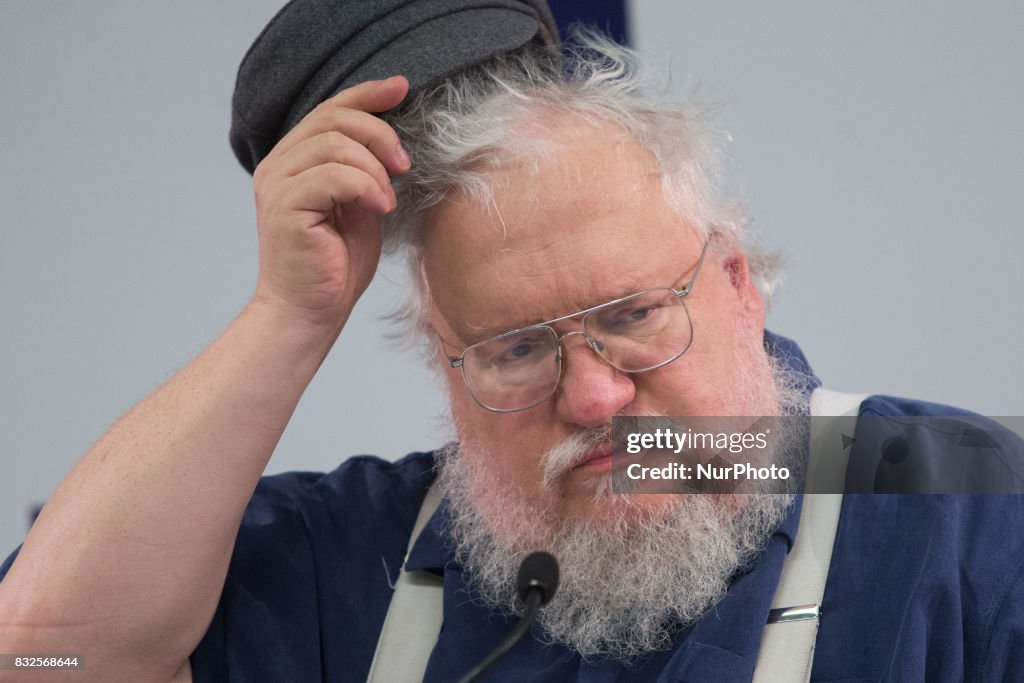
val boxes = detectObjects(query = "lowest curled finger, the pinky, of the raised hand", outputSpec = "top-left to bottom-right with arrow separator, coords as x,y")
285,163 -> 394,214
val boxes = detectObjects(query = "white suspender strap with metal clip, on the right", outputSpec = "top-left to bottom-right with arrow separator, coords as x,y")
753,389 -> 867,683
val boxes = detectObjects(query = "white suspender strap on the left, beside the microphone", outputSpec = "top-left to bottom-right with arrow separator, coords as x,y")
367,482 -> 444,683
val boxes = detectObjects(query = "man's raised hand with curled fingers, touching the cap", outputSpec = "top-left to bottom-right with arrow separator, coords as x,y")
253,76 -> 410,331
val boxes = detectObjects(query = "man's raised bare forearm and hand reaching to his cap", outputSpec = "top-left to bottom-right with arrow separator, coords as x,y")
0,79 -> 409,681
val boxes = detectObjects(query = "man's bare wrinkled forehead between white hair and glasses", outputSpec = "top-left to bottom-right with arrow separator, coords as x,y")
423,127 -> 700,342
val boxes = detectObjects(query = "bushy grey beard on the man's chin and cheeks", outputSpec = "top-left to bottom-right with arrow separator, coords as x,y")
438,364 -> 806,661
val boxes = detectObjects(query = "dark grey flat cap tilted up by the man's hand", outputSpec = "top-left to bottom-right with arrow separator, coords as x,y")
230,0 -> 558,173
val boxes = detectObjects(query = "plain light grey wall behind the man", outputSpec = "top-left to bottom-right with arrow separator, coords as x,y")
0,0 -> 1024,554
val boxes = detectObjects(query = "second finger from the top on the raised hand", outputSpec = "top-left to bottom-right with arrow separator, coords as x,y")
270,106 -> 410,175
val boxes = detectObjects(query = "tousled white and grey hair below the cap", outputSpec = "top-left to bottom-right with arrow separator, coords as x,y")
384,29 -> 781,342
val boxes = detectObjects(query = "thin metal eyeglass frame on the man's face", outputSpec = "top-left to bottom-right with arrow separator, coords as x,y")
447,240 -> 711,413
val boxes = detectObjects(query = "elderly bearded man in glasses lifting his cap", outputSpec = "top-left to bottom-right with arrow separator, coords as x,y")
0,3 -> 1024,681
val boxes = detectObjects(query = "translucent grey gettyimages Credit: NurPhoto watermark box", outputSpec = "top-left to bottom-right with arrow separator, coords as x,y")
611,415 -> 1024,494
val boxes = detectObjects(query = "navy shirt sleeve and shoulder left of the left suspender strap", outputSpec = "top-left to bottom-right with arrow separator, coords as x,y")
190,454 -> 433,683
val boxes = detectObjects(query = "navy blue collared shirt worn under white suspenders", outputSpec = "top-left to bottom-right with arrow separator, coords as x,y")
0,333 -> 1024,682
